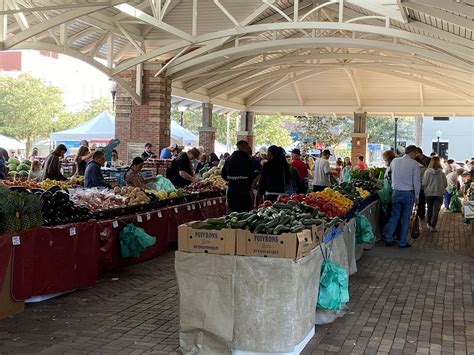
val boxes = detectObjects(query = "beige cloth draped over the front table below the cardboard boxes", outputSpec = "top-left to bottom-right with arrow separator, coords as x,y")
175,249 -> 323,354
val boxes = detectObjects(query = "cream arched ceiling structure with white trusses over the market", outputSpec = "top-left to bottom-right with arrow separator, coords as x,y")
0,0 -> 474,116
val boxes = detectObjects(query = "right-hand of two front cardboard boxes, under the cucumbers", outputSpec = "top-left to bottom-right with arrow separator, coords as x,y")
237,228 -> 317,260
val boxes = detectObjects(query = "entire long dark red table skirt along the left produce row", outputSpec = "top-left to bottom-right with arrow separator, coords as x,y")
0,197 -> 225,301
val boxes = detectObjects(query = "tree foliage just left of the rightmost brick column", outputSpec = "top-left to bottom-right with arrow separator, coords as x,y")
296,116 -> 353,147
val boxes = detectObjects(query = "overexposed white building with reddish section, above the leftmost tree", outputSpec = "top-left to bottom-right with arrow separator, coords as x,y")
0,50 -> 110,111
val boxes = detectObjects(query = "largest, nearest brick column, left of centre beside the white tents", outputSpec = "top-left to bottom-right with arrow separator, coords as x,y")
115,63 -> 171,160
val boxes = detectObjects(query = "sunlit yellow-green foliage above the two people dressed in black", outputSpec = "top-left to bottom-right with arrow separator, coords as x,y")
254,115 -> 294,147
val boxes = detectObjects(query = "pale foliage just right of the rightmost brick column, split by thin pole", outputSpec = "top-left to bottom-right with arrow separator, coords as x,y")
367,117 -> 416,146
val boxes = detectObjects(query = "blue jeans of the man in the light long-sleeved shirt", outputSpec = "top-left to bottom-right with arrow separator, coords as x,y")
386,190 -> 415,246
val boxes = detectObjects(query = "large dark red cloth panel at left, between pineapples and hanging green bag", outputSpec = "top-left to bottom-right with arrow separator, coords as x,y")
12,221 -> 99,301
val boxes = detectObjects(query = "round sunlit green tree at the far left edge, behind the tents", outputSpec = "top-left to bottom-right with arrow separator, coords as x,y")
0,74 -> 64,153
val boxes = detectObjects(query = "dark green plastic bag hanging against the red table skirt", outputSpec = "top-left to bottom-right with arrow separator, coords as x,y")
119,224 -> 156,258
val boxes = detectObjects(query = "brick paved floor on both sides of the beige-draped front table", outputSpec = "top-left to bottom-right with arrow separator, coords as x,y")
0,213 -> 474,354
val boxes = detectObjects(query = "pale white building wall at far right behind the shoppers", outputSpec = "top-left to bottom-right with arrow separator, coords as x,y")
422,117 -> 474,161
